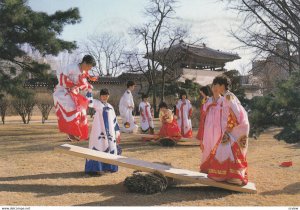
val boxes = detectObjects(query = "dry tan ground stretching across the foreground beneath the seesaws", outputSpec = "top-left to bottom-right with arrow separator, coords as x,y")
0,117 -> 300,206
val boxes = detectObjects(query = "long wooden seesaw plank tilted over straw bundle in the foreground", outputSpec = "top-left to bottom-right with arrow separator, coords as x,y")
54,144 -> 256,193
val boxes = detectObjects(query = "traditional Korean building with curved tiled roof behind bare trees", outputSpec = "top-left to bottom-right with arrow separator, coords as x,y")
145,41 -> 240,85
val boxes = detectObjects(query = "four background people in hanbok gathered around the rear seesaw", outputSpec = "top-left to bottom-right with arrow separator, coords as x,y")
115,81 -> 192,141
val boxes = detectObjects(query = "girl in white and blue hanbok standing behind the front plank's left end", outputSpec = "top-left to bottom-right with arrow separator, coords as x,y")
85,89 -> 121,175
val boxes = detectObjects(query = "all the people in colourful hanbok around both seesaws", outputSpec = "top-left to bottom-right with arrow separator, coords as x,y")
54,55 -> 249,185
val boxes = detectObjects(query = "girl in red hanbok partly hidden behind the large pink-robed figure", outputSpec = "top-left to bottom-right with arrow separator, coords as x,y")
196,85 -> 211,141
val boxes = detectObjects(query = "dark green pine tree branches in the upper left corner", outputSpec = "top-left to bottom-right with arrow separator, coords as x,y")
0,0 -> 81,95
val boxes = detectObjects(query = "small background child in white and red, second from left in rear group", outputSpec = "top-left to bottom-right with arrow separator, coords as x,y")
139,94 -> 154,134
